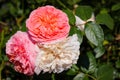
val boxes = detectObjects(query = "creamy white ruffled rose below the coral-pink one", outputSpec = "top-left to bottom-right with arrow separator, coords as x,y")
35,34 -> 80,74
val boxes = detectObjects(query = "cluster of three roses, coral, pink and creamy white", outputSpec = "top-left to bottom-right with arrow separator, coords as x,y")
6,5 -> 80,75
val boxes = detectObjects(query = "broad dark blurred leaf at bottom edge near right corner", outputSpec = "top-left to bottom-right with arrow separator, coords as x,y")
96,64 -> 114,80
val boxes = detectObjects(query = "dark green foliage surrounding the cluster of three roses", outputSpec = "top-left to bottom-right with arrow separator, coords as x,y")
0,0 -> 120,80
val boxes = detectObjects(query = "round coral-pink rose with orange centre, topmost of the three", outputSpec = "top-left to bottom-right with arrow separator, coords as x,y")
26,6 -> 70,44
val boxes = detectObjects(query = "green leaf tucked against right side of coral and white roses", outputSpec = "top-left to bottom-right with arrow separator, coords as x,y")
69,26 -> 83,44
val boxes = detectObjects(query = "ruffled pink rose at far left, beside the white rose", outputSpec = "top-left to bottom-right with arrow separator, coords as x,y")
6,31 -> 38,75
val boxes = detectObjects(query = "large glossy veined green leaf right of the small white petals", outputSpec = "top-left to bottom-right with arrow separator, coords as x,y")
85,22 -> 104,46
